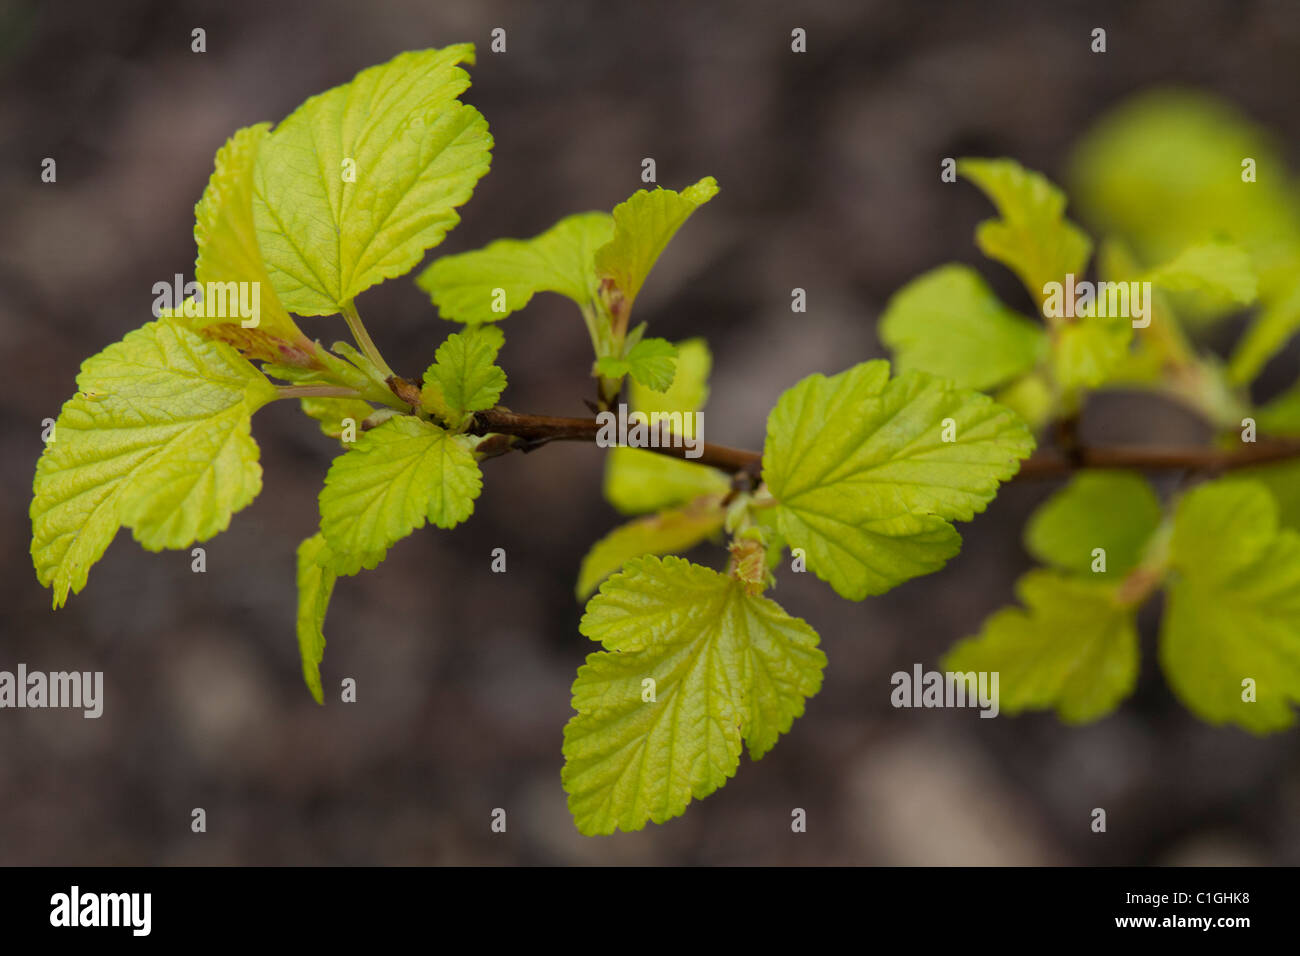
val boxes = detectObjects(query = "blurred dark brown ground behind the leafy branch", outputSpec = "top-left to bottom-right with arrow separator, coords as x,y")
0,0 -> 1300,865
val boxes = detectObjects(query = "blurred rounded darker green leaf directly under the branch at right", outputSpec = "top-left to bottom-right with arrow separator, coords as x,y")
1024,471 -> 1161,579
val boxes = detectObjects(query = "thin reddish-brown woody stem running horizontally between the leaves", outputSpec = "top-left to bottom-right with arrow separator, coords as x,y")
469,408 -> 1300,479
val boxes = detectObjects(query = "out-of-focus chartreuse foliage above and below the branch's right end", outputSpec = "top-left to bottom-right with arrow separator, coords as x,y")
904,92 -> 1300,734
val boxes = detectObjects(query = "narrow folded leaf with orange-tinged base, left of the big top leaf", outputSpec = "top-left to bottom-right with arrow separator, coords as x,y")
187,124 -> 317,365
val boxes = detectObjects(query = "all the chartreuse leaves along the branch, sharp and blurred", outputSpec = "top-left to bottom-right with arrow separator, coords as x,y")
31,55 -> 1300,834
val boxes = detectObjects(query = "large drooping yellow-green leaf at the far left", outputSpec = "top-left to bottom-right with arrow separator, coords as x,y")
30,320 -> 276,607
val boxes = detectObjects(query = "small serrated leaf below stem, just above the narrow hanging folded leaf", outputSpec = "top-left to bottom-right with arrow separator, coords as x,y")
321,415 -> 482,575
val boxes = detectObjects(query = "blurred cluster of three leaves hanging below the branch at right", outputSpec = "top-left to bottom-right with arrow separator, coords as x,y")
944,472 -> 1300,732
